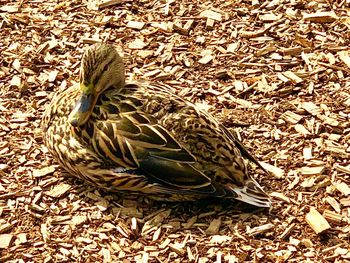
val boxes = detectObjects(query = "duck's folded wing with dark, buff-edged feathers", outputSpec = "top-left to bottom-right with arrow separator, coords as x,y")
88,104 -> 230,196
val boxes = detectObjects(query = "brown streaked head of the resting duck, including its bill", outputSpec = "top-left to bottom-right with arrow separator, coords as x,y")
69,44 -> 125,127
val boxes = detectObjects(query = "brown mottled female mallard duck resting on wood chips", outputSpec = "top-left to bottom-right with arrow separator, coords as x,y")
43,44 -> 270,207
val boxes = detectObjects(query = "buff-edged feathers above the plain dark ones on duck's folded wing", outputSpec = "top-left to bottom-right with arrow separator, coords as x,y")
92,101 -> 196,171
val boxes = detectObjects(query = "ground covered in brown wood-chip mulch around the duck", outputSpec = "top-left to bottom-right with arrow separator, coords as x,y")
0,0 -> 350,262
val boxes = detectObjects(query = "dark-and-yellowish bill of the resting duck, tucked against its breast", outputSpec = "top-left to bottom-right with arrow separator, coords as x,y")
68,94 -> 95,127
